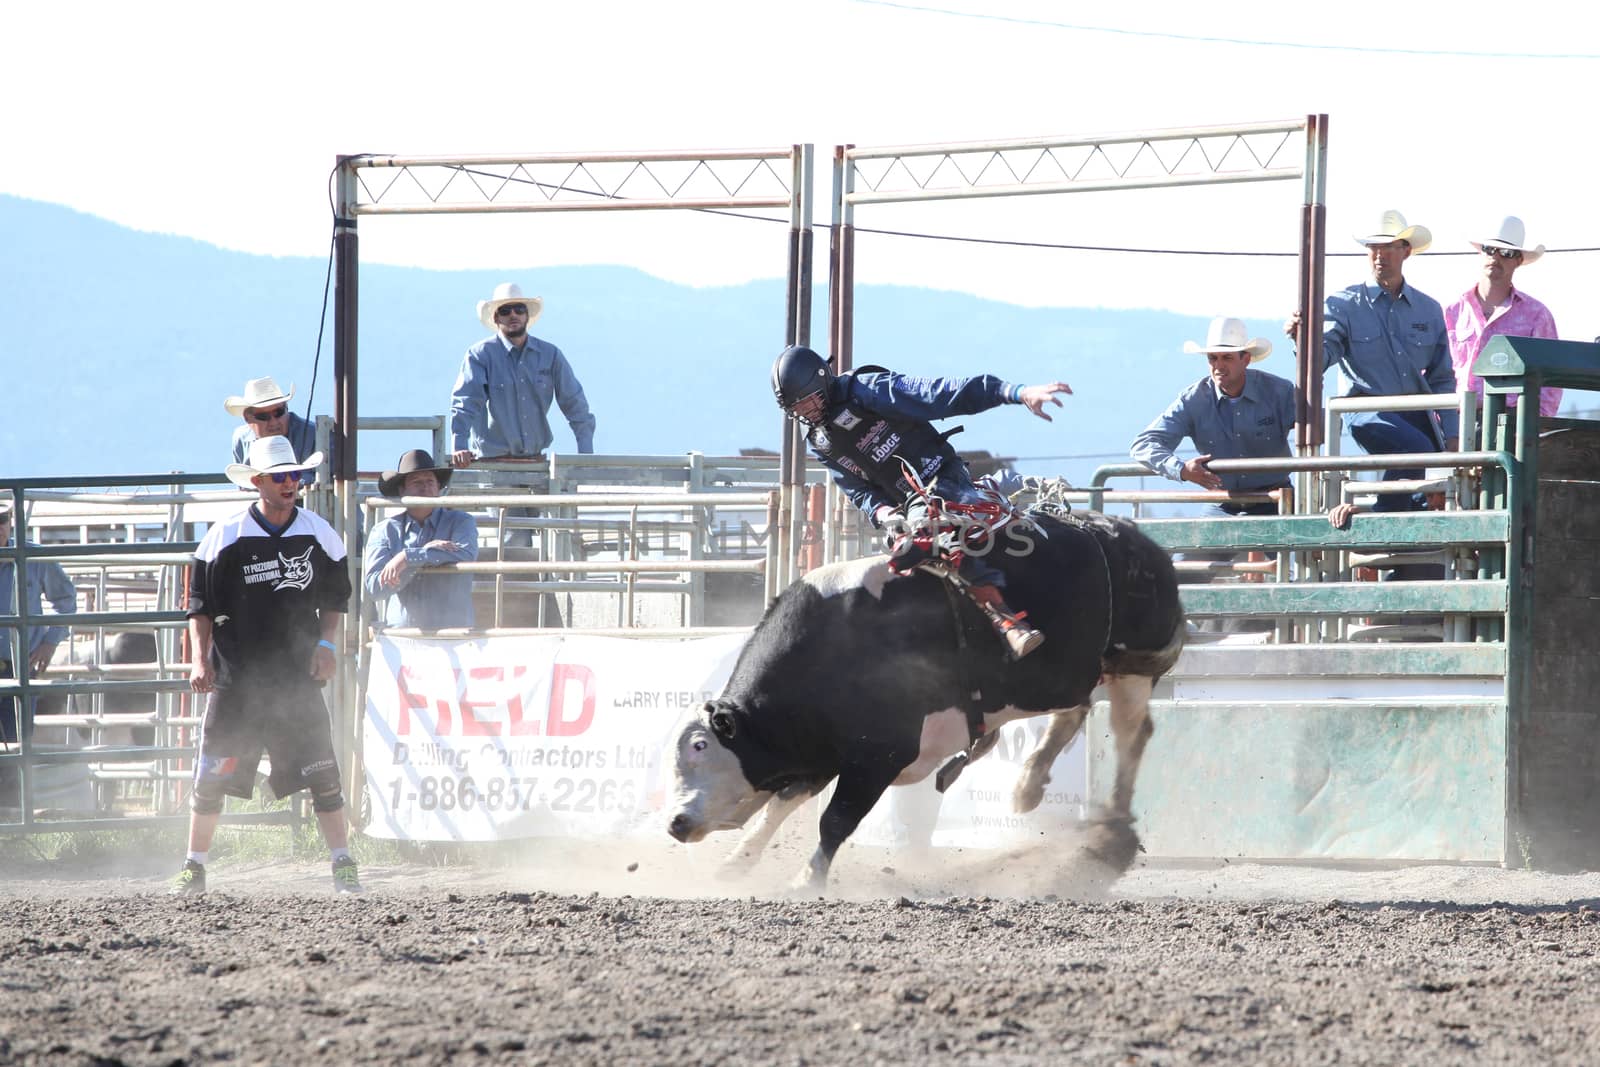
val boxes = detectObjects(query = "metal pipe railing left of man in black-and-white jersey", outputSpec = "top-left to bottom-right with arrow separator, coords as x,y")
0,472 -> 299,832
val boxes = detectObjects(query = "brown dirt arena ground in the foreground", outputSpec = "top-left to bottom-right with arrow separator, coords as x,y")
0,841 -> 1600,1065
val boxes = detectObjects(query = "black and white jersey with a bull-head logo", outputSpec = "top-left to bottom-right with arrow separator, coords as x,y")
189,506 -> 350,685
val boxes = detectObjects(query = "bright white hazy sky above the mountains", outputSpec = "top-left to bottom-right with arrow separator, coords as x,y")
0,0 -> 1600,339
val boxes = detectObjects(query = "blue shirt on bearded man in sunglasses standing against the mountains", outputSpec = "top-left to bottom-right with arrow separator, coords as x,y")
450,334 -> 595,459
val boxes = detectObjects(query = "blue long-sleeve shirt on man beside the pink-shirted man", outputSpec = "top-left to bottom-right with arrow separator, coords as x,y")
1322,280 -> 1459,445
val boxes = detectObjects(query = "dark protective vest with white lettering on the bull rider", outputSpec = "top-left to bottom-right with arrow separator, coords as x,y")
806,391 -> 962,504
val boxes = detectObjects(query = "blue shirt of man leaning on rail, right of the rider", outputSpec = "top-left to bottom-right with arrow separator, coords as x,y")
1128,370 -> 1294,490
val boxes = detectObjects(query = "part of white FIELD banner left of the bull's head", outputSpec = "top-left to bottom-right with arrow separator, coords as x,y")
362,633 -> 746,841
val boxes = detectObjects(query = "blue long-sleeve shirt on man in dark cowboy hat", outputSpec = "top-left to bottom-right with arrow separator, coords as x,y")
362,507 -> 478,630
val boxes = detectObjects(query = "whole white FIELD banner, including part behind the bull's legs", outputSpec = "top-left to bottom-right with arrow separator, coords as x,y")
363,633 -> 1088,848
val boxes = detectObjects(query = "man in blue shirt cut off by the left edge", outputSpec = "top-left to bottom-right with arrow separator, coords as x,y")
0,507 -> 78,806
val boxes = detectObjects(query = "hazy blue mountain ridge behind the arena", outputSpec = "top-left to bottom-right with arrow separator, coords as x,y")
0,195 -> 1254,482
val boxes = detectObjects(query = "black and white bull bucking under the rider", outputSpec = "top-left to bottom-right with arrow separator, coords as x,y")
667,515 -> 1186,889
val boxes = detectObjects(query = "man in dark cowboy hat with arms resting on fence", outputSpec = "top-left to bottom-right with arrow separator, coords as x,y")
362,448 -> 478,630
